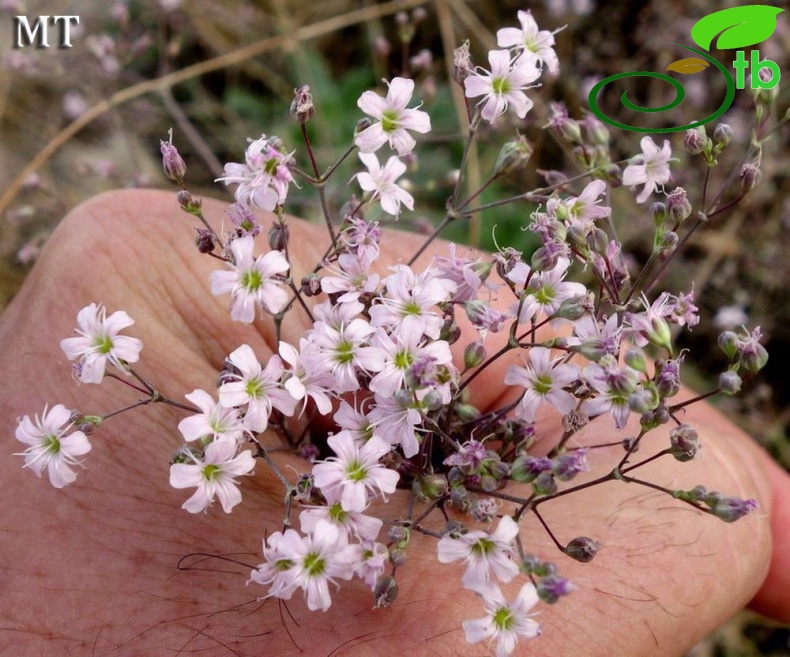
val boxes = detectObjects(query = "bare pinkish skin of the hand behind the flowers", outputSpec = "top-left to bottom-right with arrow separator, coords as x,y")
0,191 -> 790,657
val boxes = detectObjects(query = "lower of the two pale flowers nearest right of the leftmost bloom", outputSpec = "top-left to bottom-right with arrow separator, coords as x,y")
170,438 -> 255,513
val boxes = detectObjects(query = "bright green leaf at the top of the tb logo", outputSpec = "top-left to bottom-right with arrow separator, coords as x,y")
691,5 -> 784,50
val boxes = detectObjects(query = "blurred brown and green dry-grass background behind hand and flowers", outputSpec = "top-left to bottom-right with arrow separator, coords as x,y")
0,0 -> 790,657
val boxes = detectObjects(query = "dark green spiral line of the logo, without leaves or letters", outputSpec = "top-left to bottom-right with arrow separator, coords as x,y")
587,44 -> 735,133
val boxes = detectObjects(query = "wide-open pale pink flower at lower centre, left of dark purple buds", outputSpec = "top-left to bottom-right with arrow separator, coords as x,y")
313,431 -> 399,512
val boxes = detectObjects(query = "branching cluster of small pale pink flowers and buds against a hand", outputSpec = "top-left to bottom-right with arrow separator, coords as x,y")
16,6 -> 767,656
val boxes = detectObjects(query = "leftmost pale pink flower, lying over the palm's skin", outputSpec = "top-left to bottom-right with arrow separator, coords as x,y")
16,404 -> 91,488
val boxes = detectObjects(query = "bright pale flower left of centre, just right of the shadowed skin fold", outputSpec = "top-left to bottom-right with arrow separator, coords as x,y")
219,344 -> 296,432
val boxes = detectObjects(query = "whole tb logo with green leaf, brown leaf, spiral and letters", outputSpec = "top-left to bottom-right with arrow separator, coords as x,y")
587,5 -> 784,133
